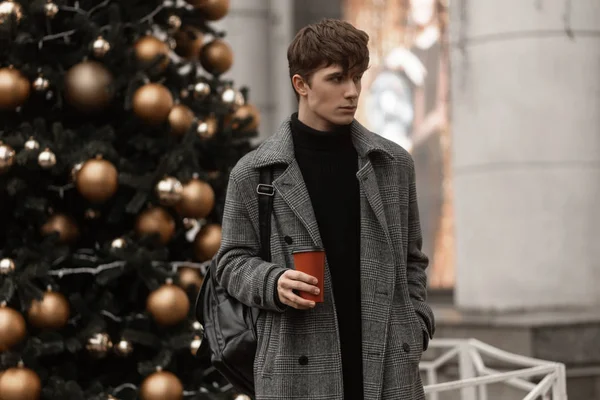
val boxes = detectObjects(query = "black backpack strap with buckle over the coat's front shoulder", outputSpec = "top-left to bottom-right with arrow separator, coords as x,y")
256,167 -> 275,261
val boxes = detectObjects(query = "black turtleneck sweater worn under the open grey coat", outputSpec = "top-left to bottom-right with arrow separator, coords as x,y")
291,113 -> 363,399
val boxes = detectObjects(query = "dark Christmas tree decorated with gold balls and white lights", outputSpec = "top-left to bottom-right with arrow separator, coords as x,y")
0,0 -> 259,400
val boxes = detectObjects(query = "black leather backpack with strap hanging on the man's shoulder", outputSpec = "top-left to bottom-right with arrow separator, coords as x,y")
196,168 -> 275,397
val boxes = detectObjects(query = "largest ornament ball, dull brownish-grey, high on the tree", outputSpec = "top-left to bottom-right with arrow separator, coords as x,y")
65,61 -> 114,113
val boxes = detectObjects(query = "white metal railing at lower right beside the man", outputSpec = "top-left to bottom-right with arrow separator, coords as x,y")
419,339 -> 567,400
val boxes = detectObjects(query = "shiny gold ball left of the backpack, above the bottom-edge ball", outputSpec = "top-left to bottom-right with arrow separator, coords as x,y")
146,283 -> 190,326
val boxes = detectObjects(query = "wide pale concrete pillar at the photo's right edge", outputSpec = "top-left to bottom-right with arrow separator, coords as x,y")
450,0 -> 600,311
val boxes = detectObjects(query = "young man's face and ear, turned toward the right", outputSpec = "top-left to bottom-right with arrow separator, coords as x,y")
293,65 -> 363,131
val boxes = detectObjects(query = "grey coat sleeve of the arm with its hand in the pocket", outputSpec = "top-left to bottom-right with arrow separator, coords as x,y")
406,158 -> 435,348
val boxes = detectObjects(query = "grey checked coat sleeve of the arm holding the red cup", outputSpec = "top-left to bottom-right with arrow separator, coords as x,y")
216,174 -> 285,312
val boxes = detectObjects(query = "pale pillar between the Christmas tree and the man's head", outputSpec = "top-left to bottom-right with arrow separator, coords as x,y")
211,0 -> 293,140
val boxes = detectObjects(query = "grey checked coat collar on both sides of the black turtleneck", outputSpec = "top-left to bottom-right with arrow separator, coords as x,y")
252,117 -> 394,168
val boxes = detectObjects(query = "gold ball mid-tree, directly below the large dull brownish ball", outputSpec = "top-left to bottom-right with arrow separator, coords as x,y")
75,158 -> 119,203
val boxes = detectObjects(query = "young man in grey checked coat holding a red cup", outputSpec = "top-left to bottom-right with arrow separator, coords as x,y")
216,20 -> 434,400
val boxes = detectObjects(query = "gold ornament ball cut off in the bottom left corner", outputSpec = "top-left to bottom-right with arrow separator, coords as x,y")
0,367 -> 42,400
